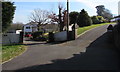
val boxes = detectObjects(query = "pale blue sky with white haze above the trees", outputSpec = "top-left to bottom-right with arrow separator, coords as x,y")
11,0 -> 120,24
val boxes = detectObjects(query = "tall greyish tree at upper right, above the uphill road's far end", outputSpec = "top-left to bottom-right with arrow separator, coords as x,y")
96,5 -> 113,20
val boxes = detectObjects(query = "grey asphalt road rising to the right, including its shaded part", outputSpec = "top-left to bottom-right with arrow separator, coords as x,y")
2,25 -> 119,70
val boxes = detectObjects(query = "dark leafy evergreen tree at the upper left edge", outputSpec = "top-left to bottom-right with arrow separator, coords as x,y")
2,2 -> 16,32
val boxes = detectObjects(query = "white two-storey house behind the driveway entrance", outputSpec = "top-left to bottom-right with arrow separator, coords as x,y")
23,22 -> 38,35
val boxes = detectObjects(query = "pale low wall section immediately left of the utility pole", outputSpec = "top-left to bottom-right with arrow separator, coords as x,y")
54,31 -> 67,41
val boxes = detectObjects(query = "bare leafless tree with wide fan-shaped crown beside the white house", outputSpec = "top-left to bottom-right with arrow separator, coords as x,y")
30,9 -> 49,31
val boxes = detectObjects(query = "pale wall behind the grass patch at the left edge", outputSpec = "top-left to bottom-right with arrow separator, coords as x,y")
2,33 -> 20,44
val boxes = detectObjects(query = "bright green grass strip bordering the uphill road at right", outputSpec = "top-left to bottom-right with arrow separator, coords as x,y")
77,23 -> 114,35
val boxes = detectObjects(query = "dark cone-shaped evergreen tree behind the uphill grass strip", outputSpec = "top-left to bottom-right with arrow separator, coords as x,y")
77,9 -> 92,27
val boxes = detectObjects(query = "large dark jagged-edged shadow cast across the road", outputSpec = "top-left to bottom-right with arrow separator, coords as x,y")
16,33 -> 119,72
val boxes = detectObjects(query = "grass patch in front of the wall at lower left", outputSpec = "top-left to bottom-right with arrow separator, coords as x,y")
2,45 -> 26,63
